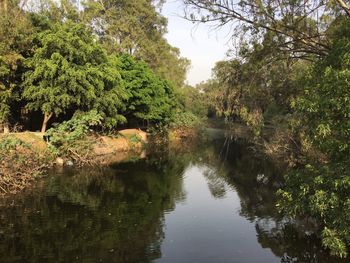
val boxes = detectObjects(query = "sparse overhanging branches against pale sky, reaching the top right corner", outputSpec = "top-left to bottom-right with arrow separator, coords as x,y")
184,0 -> 350,58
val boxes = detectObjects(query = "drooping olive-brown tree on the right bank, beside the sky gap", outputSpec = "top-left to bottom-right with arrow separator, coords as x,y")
203,32 -> 305,134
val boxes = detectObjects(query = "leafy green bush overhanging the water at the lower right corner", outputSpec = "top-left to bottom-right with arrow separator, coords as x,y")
278,162 -> 350,257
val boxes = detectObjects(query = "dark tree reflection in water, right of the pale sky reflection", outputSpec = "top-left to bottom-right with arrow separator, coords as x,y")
195,133 -> 347,263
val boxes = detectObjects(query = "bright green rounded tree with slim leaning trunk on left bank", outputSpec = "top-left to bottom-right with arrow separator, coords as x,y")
23,21 -> 126,132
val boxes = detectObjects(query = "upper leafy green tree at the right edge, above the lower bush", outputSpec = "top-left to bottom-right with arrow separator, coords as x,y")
295,17 -> 350,159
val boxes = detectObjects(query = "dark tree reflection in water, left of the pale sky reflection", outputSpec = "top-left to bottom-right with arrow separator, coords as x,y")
0,158 -> 185,262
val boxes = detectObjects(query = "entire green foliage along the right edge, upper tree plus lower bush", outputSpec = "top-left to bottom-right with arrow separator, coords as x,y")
279,17 -> 350,257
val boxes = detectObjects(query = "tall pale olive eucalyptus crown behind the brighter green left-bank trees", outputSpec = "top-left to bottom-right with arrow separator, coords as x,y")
82,0 -> 189,87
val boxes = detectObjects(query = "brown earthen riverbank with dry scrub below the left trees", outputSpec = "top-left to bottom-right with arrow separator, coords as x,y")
0,129 -> 148,195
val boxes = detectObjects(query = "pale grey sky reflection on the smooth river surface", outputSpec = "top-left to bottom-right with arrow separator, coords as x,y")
155,165 -> 280,263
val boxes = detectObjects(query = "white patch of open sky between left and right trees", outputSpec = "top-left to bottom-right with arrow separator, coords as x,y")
162,0 -> 229,85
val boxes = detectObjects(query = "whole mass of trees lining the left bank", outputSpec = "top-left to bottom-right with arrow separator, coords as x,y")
0,0 -> 194,132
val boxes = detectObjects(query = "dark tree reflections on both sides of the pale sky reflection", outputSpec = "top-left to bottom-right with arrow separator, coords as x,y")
0,130 -> 346,262
